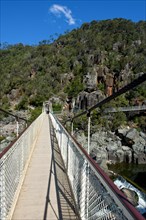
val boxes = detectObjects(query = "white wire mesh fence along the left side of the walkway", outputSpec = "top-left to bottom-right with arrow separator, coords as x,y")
0,113 -> 45,220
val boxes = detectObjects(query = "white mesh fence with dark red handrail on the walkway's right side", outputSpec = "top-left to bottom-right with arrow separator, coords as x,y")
50,113 -> 144,220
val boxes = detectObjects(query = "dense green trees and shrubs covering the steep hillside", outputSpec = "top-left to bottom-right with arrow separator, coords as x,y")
0,19 -> 146,129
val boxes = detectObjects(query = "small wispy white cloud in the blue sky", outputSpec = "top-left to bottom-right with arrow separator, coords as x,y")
49,5 -> 75,25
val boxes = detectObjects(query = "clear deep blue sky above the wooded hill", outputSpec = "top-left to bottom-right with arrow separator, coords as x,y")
0,0 -> 146,45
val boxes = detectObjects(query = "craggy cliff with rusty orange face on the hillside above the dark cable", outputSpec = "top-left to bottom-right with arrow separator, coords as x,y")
77,60 -> 136,109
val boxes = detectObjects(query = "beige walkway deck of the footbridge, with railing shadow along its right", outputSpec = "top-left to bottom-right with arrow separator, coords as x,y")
12,115 -> 78,220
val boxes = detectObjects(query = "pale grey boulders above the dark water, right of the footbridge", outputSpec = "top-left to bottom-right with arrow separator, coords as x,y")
76,129 -> 146,167
